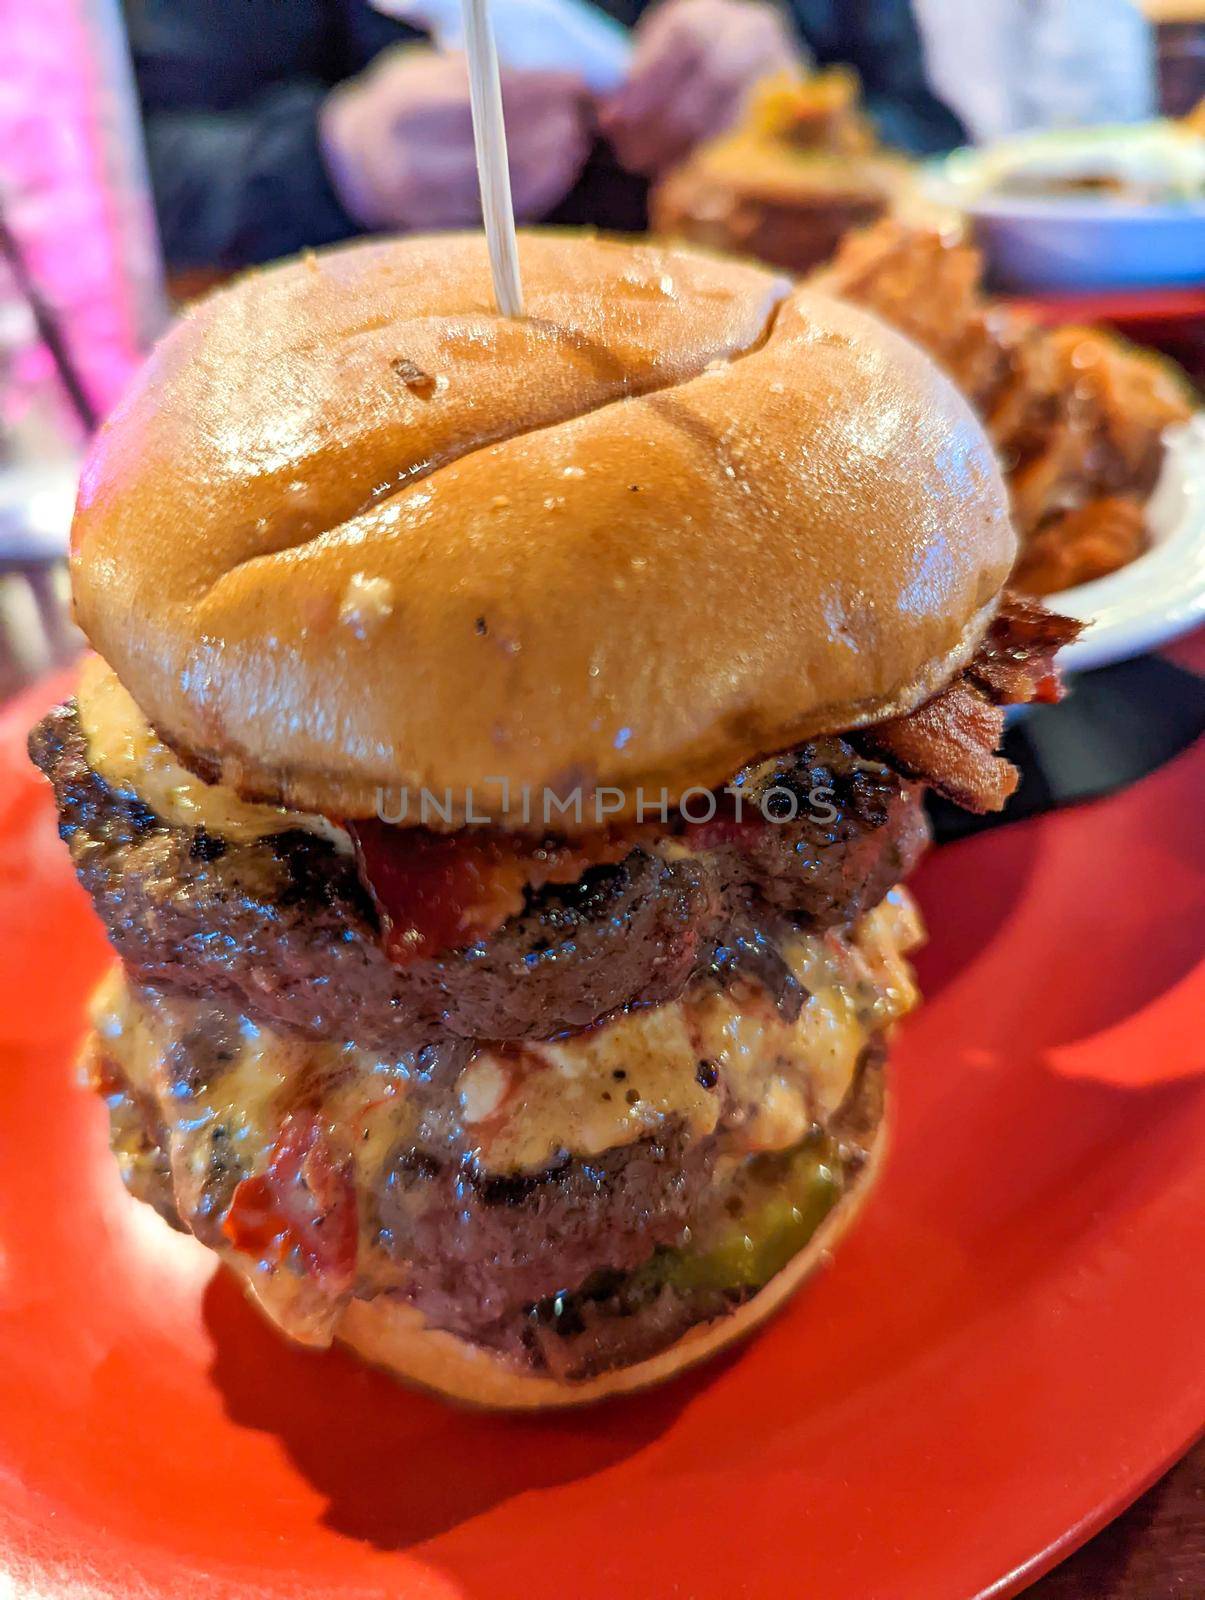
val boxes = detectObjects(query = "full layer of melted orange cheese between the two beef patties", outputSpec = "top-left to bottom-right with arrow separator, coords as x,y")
93,890 -> 920,1203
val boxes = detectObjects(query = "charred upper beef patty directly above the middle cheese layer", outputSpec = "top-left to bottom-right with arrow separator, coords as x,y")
30,701 -> 927,1051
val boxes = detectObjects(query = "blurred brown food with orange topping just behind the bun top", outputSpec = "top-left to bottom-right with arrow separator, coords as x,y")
651,67 -> 912,272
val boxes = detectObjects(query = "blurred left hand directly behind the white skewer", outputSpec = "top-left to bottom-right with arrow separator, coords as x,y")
320,46 -> 592,229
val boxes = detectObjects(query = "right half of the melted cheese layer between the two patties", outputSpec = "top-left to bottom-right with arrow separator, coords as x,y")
458,890 -> 920,1173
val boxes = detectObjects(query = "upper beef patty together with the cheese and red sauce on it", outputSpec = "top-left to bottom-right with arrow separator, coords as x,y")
32,667 -> 927,1050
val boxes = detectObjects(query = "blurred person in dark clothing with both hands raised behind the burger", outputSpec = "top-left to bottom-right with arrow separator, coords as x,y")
126,0 -> 963,269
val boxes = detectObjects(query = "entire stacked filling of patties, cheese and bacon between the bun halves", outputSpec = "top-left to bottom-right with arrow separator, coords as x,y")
30,600 -> 1075,1379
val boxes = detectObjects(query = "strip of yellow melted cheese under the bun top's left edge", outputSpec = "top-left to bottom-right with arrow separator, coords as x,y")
75,656 -> 352,853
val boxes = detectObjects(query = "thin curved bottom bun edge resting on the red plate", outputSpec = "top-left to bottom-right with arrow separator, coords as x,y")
326,1118 -> 887,1411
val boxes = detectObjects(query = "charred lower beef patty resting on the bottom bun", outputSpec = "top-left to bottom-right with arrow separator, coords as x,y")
376,1038 -> 885,1379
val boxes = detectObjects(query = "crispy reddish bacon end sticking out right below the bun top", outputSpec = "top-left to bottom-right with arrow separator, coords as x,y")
856,594 -> 1082,811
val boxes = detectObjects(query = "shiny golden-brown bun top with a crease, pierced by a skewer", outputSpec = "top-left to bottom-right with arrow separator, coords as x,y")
72,235 -> 1015,832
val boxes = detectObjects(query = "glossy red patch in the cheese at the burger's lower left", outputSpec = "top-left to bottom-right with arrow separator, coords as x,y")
222,1112 -> 358,1294
